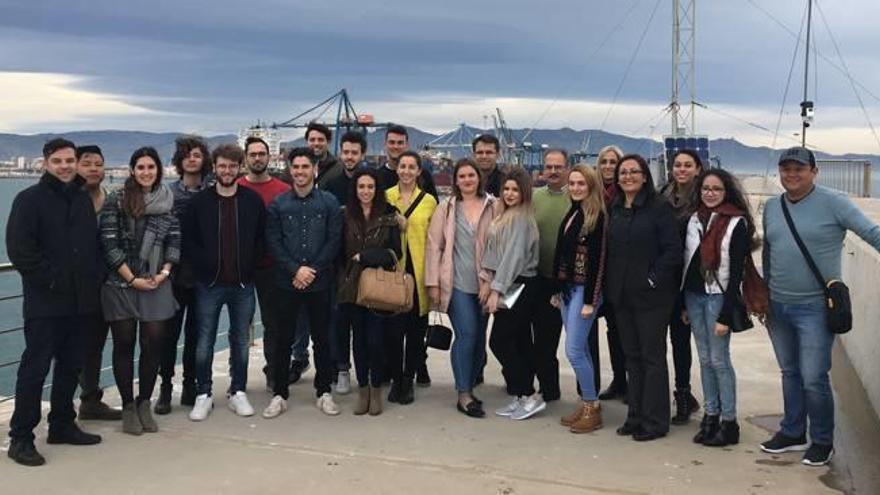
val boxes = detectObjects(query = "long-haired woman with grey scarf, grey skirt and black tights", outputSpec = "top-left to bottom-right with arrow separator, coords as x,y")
101,147 -> 180,435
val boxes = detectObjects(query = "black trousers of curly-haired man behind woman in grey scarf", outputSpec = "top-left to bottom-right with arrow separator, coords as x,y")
159,285 -> 199,390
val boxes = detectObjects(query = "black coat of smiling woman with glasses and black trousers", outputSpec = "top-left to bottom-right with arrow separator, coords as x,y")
605,189 -> 683,308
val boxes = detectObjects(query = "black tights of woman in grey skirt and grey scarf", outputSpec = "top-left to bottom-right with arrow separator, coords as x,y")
110,319 -> 165,404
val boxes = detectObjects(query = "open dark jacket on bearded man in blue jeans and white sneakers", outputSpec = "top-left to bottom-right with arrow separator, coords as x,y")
182,186 -> 266,285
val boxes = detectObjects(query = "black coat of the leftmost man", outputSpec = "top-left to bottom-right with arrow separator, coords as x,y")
6,173 -> 104,318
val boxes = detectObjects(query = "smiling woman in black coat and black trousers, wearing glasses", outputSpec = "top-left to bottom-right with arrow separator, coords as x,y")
605,155 -> 682,441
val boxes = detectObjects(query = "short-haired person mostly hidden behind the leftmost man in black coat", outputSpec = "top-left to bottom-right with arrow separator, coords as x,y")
76,145 -> 122,421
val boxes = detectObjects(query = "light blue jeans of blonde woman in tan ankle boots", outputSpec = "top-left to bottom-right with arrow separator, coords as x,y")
560,285 -> 602,400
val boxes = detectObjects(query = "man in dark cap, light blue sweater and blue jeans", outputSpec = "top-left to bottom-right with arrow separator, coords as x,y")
761,147 -> 880,466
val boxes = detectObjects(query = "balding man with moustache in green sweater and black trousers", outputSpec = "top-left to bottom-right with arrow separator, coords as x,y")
532,149 -> 571,402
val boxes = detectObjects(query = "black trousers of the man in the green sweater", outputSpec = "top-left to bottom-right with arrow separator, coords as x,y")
525,276 -> 564,400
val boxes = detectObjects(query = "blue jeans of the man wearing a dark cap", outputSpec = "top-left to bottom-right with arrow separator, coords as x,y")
768,299 -> 834,445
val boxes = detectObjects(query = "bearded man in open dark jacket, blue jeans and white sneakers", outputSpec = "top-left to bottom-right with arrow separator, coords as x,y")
183,144 -> 266,421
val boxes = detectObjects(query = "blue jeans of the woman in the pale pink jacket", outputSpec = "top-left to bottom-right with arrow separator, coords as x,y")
449,289 -> 488,392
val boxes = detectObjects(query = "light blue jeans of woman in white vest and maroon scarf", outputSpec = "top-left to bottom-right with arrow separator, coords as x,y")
688,291 -> 736,421
